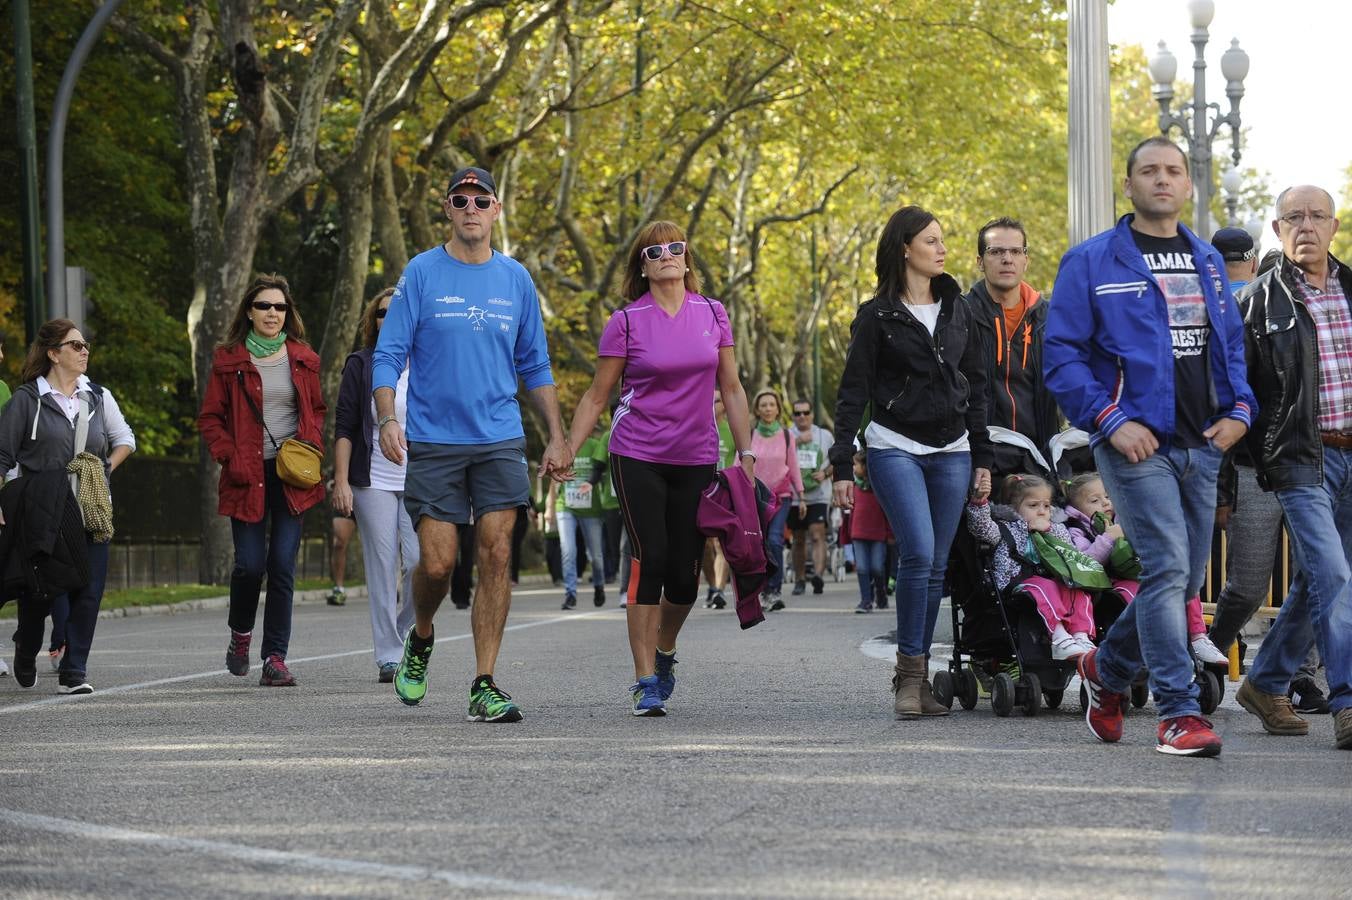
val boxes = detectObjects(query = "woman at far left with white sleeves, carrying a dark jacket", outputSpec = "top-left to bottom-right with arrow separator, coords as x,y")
0,319 -> 137,695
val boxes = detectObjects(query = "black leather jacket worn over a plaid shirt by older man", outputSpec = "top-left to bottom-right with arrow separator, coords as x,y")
1237,257 -> 1352,491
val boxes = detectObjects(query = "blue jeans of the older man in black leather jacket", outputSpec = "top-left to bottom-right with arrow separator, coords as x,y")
1248,447 -> 1352,712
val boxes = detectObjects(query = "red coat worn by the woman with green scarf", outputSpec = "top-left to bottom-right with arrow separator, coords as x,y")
197,338 -> 324,522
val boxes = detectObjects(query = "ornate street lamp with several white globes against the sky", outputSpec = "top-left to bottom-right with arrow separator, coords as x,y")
1151,0 -> 1249,239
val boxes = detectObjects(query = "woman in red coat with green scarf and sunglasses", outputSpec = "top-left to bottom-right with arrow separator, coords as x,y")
197,274 -> 324,686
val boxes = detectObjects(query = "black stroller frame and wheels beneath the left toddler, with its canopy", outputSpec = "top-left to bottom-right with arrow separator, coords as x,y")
933,427 -> 1075,716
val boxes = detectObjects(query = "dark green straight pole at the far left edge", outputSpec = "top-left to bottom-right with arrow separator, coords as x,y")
9,0 -> 47,343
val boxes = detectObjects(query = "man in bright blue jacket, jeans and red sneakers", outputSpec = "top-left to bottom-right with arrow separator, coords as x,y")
1044,136 -> 1256,757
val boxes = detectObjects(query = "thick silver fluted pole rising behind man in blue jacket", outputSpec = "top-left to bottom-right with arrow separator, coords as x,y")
1065,0 -> 1113,245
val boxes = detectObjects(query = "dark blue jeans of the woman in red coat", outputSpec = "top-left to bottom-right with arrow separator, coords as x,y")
228,459 -> 301,659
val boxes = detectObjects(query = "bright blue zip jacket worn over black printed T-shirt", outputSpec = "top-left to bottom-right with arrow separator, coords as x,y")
1042,215 -> 1256,445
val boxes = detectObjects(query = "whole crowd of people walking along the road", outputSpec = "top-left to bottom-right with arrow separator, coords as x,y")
0,138 -> 1352,755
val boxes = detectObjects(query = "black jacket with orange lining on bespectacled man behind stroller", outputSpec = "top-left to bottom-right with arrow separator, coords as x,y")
967,281 -> 1061,474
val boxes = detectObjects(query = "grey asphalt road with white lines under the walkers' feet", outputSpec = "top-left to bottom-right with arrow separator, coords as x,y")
0,584 -> 1352,900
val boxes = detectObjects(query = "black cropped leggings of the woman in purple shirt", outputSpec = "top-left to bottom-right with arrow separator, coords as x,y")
610,454 -> 714,605
